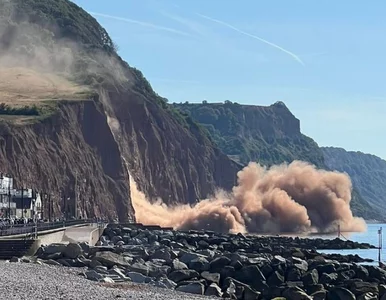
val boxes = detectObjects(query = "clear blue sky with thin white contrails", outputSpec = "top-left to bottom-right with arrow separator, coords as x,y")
74,0 -> 386,159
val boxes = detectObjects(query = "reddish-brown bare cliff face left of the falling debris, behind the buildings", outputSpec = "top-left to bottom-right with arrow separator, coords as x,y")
0,101 -> 134,220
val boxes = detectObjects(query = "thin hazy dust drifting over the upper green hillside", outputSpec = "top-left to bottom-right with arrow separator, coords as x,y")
0,0 -> 132,94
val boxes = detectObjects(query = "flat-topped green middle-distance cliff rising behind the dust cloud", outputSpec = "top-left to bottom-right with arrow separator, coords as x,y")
174,101 -> 324,167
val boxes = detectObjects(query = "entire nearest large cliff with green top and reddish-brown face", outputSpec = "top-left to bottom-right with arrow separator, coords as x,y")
0,0 -> 241,220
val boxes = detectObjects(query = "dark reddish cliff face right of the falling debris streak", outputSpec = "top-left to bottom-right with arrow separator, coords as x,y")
101,90 -> 241,204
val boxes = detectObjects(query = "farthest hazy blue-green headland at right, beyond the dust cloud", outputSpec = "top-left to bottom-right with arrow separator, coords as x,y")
321,147 -> 386,214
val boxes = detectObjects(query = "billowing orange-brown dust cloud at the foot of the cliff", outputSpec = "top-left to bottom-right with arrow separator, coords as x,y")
130,161 -> 366,233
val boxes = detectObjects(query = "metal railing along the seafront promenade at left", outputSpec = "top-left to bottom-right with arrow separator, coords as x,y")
0,219 -> 95,237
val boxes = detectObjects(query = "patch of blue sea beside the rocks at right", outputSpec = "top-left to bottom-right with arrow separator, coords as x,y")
312,224 -> 386,264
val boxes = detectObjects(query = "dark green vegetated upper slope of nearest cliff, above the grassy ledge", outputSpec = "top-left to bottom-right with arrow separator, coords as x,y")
0,0 -> 193,130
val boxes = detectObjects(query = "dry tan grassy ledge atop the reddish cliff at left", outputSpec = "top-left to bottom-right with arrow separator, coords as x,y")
0,67 -> 94,124
